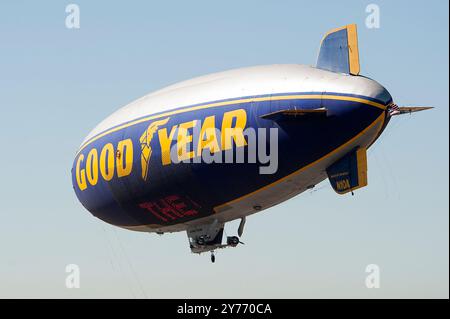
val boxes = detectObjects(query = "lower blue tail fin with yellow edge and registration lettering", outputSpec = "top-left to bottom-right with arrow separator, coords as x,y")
327,148 -> 367,194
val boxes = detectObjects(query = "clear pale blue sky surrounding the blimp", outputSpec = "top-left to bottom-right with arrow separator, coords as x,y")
0,0 -> 449,298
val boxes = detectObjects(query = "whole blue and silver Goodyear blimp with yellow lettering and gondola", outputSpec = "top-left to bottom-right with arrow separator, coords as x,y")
72,24 -> 430,262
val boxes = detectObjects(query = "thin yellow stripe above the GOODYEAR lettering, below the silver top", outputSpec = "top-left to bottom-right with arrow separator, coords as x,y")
76,94 -> 386,155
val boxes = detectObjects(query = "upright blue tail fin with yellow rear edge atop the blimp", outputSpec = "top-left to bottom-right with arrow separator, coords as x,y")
316,24 -> 360,75
